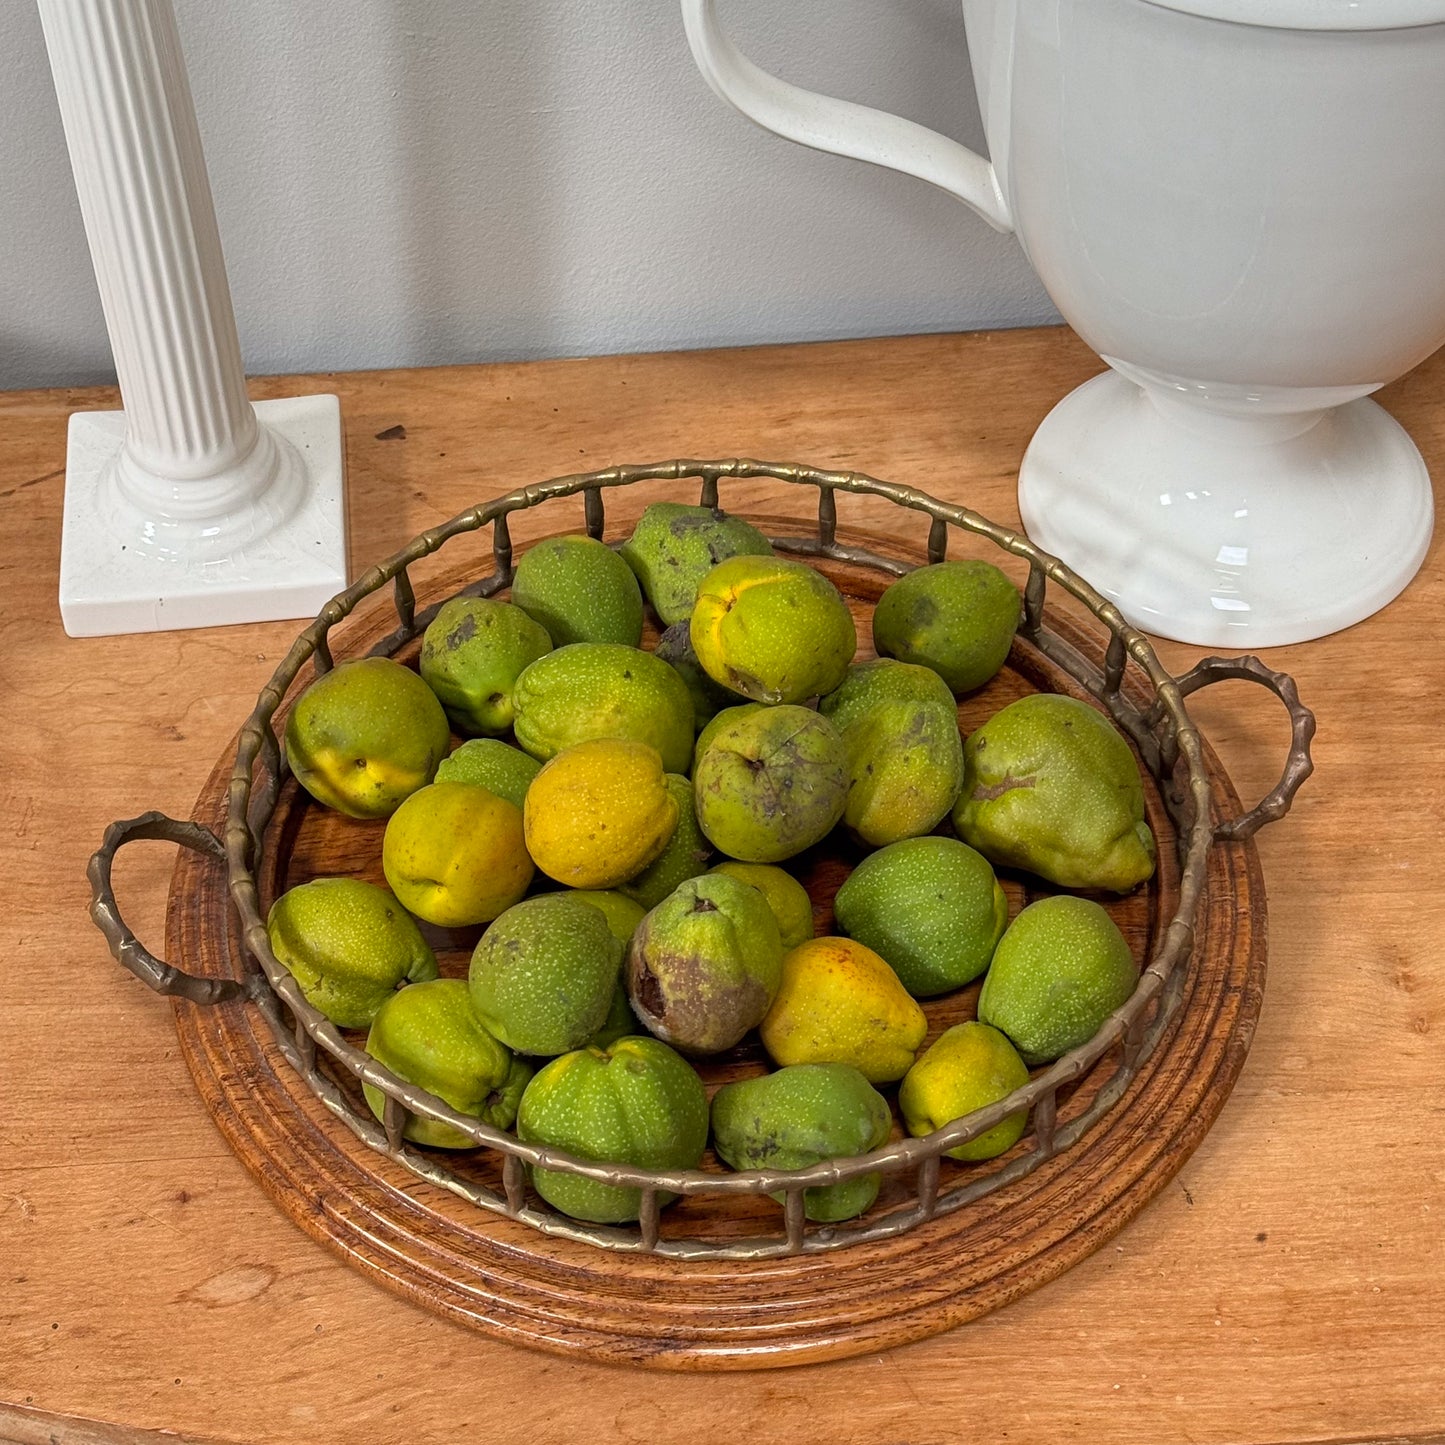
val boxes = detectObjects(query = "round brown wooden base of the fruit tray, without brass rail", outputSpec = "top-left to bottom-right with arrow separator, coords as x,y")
155,549 -> 1266,1370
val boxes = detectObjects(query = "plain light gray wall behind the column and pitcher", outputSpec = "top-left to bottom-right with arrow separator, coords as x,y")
0,0 -> 1055,389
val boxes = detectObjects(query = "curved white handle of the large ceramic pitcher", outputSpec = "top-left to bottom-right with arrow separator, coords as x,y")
682,0 -> 1013,231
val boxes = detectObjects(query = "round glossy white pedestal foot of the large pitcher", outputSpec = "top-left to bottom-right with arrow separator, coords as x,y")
1019,371 -> 1433,649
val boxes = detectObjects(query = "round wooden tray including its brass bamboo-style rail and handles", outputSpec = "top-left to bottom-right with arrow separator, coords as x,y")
84,461 -> 1314,1370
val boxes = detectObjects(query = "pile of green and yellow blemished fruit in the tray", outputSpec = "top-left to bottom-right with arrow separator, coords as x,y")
267,503 -> 1155,1222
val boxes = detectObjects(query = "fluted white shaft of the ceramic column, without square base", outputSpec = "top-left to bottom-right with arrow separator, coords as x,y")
38,0 -> 257,488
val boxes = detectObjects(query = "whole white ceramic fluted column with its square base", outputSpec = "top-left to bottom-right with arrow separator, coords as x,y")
39,0 -> 345,636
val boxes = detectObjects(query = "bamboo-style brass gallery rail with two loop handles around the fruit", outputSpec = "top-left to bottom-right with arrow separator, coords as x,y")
91,460 -> 1314,1260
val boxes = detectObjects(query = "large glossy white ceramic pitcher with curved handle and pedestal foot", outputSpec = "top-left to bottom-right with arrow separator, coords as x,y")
682,0 -> 1445,646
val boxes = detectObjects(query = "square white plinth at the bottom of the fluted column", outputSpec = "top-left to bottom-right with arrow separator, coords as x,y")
61,396 -> 347,637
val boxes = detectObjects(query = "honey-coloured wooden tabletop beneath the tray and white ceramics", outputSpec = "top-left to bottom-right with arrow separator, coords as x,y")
0,329 -> 1445,1445
